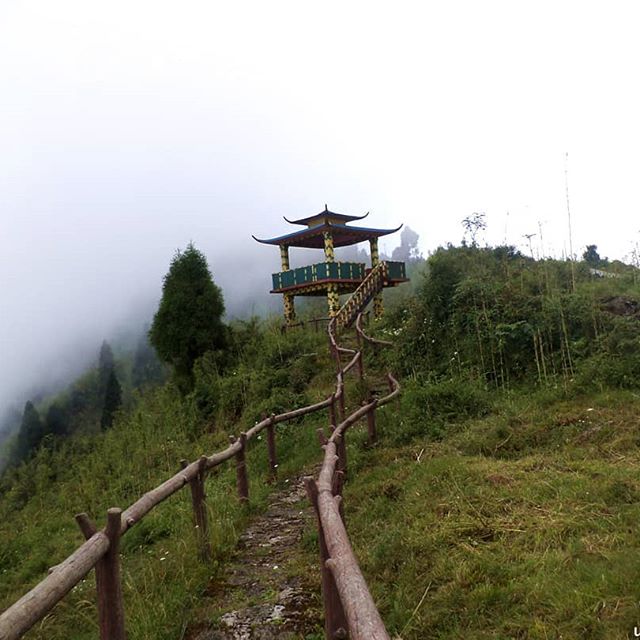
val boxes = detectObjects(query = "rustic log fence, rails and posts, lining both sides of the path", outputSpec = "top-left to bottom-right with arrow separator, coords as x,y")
0,314 -> 400,640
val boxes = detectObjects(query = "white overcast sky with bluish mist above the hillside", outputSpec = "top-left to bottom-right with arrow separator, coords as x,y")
0,0 -> 640,405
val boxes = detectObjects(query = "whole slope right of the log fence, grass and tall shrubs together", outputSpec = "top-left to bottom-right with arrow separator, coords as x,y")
330,247 -> 640,640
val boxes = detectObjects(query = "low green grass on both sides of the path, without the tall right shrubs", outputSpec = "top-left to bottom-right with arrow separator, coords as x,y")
0,302 -> 640,640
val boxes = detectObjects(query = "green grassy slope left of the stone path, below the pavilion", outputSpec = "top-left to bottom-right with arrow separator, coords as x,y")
0,323 -> 333,639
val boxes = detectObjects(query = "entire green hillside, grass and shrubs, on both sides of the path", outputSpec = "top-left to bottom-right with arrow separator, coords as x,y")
0,246 -> 640,640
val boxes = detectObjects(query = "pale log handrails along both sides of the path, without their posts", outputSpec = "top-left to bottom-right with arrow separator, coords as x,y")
0,313 -> 400,640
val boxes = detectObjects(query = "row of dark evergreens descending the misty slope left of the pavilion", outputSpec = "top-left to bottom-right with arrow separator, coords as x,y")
9,244 -> 222,465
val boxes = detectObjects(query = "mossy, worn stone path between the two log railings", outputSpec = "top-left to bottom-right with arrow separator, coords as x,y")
184,475 -> 323,640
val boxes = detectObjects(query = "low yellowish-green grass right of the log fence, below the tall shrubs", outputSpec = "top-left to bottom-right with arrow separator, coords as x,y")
345,392 -> 640,640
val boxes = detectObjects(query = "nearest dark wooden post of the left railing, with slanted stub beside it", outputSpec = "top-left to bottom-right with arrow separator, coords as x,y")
76,508 -> 126,640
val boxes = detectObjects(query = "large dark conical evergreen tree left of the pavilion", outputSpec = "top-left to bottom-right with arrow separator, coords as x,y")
149,244 -> 227,392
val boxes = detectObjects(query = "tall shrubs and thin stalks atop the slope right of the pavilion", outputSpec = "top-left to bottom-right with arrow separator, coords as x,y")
387,246 -> 640,392
